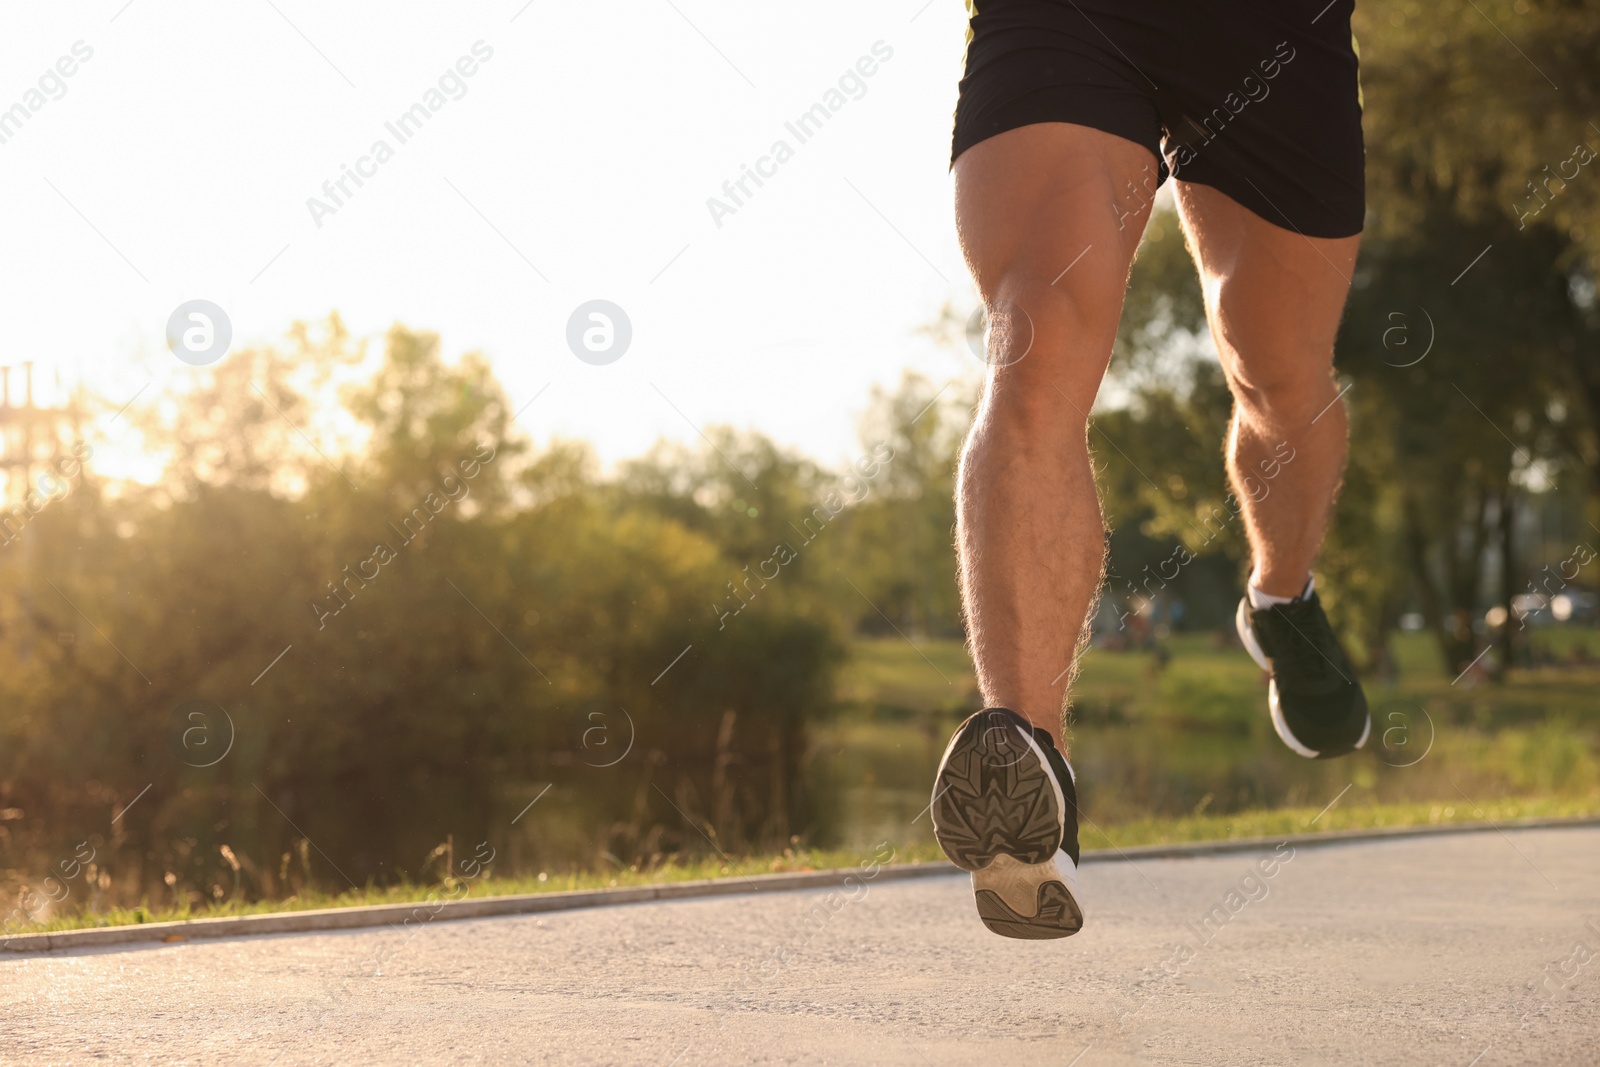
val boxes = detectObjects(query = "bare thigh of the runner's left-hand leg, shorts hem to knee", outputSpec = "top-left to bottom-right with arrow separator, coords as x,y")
954,122 -> 1155,411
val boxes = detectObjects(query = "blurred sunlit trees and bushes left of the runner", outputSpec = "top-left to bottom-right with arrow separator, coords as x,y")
0,317 -> 963,901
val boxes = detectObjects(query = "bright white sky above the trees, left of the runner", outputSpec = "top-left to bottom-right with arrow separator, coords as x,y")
0,0 -> 978,476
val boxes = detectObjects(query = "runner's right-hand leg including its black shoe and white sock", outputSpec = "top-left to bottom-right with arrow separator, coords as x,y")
1178,182 -> 1373,758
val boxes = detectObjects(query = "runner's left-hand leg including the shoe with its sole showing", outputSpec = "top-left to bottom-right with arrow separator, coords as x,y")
928,123 -> 1155,939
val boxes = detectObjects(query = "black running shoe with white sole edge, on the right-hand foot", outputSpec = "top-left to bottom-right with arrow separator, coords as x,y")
1235,590 -> 1373,760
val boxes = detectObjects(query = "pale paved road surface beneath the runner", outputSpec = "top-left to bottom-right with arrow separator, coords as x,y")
0,829 -> 1600,1067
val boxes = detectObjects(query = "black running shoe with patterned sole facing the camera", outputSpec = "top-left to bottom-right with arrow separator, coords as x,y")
930,707 -> 1083,939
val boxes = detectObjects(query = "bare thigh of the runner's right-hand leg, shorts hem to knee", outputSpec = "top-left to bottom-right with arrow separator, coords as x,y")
1176,181 -> 1362,390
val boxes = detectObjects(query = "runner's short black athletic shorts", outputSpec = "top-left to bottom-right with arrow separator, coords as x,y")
950,0 -> 1366,237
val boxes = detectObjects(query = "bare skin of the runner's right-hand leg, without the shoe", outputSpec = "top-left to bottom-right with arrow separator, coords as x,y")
1176,182 -> 1360,597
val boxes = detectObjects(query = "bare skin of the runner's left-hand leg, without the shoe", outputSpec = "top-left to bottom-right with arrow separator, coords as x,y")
955,123 -> 1155,750
